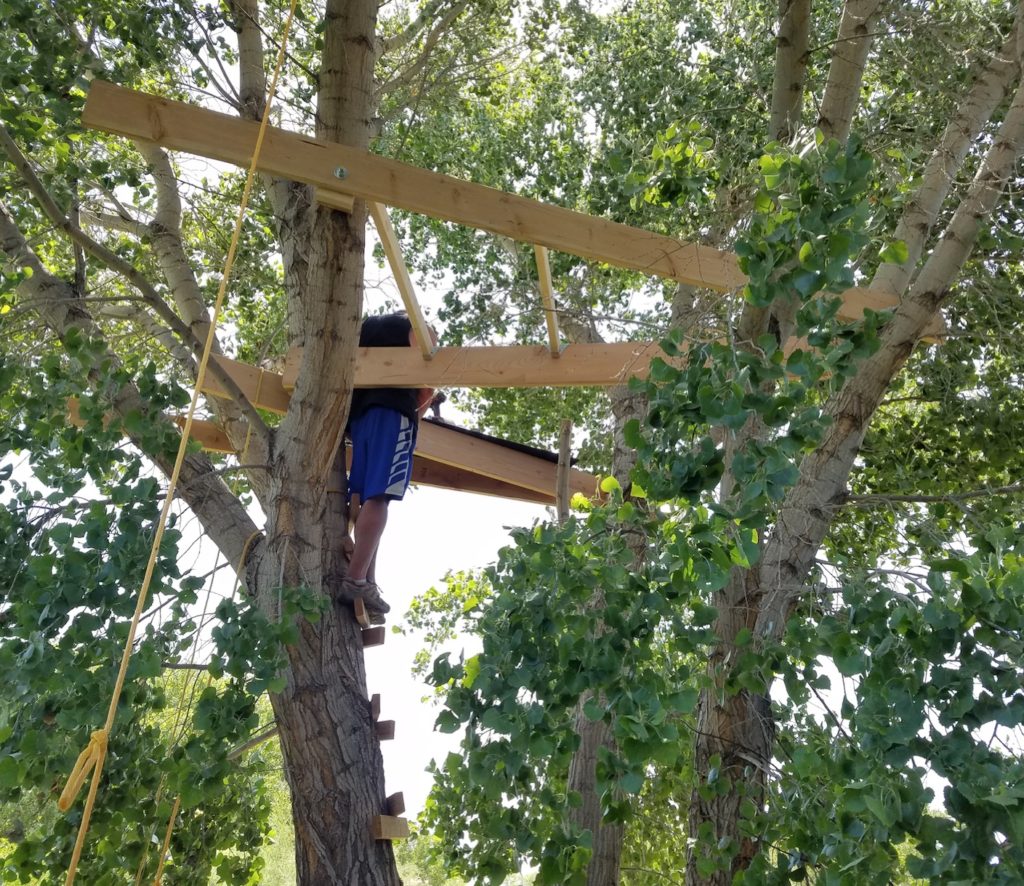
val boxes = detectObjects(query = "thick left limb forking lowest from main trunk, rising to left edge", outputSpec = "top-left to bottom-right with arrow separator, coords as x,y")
0,203 -> 258,562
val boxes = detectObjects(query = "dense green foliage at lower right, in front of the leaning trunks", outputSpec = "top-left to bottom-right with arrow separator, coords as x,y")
413,122 -> 1024,886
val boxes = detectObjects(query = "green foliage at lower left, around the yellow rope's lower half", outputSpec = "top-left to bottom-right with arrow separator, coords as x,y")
0,335 -> 299,884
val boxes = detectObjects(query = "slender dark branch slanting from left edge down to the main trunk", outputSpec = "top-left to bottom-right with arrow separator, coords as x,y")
0,124 -> 271,451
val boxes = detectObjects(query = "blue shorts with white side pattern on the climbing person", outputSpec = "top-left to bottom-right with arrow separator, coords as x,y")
348,407 -> 416,502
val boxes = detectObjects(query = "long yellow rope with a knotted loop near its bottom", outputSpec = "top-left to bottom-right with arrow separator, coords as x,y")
57,0 -> 298,886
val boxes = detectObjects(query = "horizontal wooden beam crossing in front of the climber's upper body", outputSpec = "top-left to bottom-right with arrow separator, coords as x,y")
282,341 -> 665,390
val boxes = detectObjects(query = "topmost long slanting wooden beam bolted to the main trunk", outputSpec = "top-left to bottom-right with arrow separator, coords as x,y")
82,80 -> 745,291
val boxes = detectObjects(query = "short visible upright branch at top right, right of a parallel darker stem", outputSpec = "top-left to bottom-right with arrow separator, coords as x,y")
818,0 -> 882,141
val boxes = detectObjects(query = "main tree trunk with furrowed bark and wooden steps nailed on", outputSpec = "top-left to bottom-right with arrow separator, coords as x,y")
228,0 -> 399,886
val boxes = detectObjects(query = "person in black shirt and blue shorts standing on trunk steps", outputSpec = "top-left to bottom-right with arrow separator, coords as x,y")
342,312 -> 437,624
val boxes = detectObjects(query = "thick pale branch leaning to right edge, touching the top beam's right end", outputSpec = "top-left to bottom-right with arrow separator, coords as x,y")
757,67 -> 1024,639
